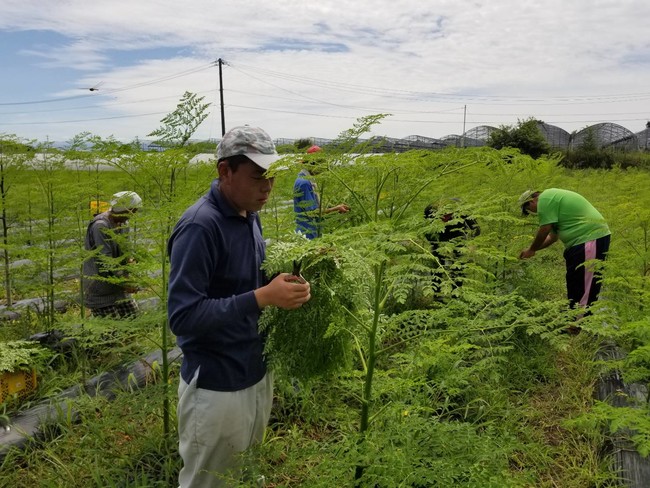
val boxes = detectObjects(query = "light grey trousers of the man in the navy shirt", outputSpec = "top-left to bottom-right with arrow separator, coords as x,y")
176,371 -> 273,488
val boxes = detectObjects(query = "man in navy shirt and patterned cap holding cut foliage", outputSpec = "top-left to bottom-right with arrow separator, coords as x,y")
168,126 -> 311,488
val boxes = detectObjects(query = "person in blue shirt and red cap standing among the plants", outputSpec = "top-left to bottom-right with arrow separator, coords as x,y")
293,146 -> 350,239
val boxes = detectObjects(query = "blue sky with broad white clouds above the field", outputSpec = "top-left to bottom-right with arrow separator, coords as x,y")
0,0 -> 650,142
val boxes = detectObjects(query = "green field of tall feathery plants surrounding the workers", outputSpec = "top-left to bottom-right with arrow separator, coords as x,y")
0,131 -> 650,488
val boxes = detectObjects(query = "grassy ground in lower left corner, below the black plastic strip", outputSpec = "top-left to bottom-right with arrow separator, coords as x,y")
0,376 -> 180,488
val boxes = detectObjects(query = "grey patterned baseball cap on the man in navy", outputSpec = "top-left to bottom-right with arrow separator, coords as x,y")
217,125 -> 280,169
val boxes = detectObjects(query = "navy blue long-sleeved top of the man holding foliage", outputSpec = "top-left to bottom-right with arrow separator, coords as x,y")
167,180 -> 266,391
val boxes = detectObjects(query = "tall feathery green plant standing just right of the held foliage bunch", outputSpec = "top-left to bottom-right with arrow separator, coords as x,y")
260,116 -> 478,480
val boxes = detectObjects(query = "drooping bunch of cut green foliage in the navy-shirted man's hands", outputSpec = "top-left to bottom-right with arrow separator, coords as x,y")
259,236 -> 355,381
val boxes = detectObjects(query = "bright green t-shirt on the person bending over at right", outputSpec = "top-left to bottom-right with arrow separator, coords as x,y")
537,188 -> 610,248
